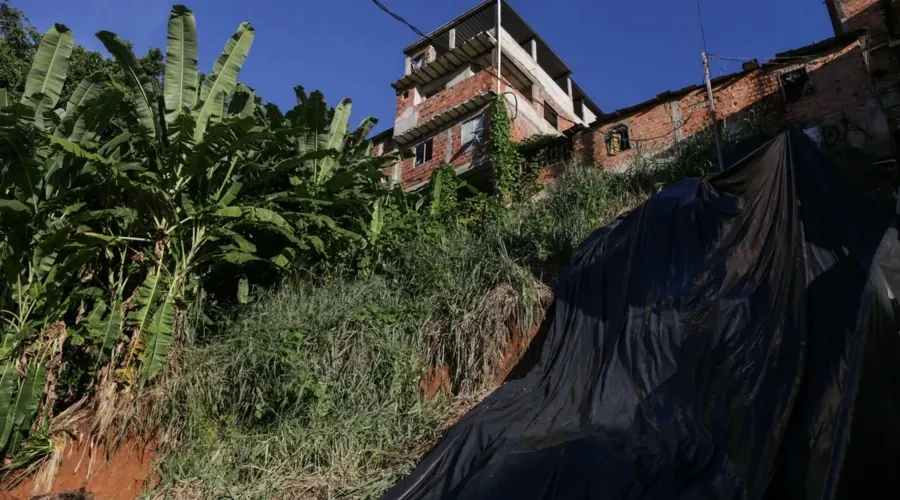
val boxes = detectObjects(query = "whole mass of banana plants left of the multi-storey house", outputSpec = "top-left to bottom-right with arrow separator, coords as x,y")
0,2 -> 403,480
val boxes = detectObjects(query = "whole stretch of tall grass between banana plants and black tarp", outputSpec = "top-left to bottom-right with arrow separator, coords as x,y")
156,132 -> 711,498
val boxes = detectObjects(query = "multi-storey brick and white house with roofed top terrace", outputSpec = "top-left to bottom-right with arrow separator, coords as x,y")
373,0 -> 602,189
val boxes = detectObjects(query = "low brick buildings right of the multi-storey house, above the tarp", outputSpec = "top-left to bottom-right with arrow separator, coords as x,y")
573,0 -> 900,169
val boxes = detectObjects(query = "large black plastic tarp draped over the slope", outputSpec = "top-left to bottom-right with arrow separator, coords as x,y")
386,131 -> 900,499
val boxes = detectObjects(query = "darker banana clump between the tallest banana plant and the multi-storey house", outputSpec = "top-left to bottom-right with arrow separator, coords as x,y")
248,86 -> 410,265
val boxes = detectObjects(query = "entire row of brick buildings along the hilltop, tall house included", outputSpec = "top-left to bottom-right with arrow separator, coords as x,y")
374,0 -> 900,189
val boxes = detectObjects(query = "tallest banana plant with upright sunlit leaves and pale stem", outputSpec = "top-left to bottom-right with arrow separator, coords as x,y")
85,5 -> 264,380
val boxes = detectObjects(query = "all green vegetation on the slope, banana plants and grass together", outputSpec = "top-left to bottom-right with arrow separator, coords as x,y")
0,3 -> 714,498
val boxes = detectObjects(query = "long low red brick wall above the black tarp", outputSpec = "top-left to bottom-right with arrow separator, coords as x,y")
573,38 -> 873,168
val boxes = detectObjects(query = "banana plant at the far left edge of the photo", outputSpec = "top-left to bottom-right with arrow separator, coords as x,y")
0,16 -> 137,464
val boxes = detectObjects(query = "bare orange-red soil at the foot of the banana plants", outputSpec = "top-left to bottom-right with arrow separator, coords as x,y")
0,440 -> 156,500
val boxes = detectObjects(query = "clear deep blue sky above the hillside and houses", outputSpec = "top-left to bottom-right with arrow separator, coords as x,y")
21,0 -> 833,130
